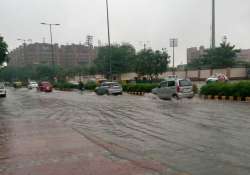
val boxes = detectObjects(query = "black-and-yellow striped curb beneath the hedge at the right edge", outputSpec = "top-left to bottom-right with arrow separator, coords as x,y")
200,95 -> 250,102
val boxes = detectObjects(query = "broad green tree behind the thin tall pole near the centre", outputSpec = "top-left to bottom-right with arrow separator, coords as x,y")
94,44 -> 136,75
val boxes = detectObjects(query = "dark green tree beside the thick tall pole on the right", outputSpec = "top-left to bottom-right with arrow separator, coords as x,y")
188,42 -> 240,68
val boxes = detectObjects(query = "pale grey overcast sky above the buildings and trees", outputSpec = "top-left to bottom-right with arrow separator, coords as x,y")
0,0 -> 250,63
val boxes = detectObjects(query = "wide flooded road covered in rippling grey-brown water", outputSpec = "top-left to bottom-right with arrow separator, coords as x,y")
0,89 -> 250,175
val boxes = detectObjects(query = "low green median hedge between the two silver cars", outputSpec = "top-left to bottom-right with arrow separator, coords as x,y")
122,84 -> 159,93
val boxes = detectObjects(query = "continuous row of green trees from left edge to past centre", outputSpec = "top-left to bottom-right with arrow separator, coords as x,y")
0,43 -> 170,81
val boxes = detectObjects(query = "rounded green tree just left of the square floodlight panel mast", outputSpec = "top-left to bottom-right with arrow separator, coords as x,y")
135,49 -> 170,79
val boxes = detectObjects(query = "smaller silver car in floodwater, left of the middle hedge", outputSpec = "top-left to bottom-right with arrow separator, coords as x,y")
95,82 -> 123,95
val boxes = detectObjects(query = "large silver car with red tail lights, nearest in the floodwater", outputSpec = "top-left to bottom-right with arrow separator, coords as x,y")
152,78 -> 194,100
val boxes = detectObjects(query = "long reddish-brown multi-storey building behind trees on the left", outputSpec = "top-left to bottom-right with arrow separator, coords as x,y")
9,43 -> 96,67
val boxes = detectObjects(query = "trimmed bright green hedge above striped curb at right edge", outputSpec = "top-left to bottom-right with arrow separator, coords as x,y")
201,81 -> 250,97
